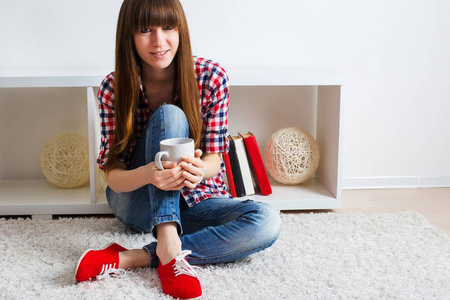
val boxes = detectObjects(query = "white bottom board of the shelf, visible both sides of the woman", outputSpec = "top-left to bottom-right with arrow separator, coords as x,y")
0,178 -> 341,215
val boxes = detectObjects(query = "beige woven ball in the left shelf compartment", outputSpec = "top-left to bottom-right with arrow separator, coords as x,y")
41,132 -> 89,188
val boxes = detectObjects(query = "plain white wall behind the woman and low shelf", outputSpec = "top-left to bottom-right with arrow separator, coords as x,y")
0,0 -> 450,188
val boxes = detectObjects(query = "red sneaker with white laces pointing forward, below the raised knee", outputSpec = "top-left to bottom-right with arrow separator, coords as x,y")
158,250 -> 202,299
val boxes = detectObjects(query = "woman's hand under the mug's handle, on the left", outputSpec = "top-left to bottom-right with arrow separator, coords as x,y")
146,161 -> 185,191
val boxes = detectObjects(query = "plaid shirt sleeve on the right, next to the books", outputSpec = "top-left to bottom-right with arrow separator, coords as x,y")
200,64 -> 230,153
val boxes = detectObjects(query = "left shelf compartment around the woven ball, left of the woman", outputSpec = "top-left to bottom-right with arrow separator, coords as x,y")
0,87 -> 90,215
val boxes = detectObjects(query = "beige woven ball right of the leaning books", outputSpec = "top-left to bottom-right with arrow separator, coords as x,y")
264,127 -> 320,185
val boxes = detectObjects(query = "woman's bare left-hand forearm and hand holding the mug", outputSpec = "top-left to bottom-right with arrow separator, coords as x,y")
106,161 -> 185,193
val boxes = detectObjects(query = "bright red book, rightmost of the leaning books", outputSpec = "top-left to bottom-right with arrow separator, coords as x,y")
239,132 -> 272,196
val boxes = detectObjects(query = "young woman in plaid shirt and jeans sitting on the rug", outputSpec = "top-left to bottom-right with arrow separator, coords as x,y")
75,0 -> 281,299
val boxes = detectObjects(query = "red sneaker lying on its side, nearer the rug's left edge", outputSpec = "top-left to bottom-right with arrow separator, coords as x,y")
74,243 -> 128,281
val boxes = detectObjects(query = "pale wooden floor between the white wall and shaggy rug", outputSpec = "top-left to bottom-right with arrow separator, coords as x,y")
284,188 -> 450,235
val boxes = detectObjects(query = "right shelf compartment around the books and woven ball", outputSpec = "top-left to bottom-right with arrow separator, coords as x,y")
228,85 -> 342,210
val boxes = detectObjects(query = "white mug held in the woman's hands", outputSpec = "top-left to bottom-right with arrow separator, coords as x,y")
155,138 -> 195,170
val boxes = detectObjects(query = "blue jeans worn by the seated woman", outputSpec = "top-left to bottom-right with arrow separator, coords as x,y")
106,105 -> 281,267
